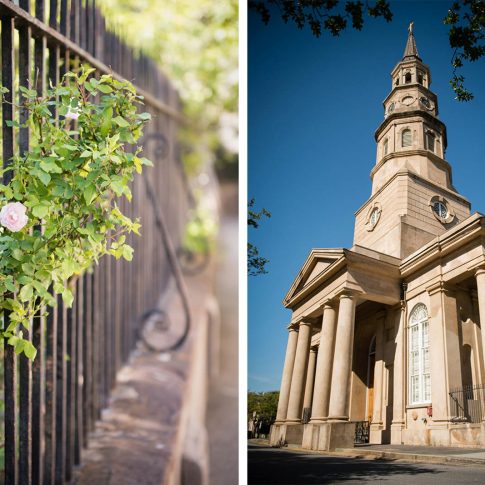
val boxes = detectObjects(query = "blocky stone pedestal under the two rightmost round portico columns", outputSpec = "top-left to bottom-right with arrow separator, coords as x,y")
302,421 -> 355,451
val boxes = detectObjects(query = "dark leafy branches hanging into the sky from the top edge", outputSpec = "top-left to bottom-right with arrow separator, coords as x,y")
248,0 -> 485,101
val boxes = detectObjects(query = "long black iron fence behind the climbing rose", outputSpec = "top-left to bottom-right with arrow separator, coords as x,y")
0,0 -> 189,484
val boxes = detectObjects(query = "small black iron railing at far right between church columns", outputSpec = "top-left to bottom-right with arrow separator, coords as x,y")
449,384 -> 485,423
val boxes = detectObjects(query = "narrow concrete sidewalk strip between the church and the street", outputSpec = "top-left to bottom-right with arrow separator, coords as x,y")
249,440 -> 485,466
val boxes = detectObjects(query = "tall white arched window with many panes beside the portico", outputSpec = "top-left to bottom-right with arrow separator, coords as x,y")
408,303 -> 431,404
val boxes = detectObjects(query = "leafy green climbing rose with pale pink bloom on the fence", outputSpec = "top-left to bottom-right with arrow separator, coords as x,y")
0,66 -> 151,359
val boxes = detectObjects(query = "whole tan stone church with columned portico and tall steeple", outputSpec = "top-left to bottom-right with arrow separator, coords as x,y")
271,24 -> 485,450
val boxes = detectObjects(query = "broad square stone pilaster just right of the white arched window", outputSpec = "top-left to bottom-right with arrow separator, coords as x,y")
428,282 -> 462,424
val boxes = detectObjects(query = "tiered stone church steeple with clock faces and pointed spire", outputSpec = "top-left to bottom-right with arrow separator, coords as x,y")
354,23 -> 470,258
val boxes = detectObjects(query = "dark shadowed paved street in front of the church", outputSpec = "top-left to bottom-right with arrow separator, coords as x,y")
248,445 -> 485,485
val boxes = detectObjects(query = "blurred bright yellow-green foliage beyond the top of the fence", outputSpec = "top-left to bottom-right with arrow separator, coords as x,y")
99,0 -> 238,177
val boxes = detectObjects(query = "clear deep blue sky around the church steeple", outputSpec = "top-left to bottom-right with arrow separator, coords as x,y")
248,1 -> 485,391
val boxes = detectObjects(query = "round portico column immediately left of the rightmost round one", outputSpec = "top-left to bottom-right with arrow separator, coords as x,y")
311,303 -> 337,423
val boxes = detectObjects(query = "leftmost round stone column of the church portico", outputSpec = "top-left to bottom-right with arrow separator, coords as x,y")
286,322 -> 312,423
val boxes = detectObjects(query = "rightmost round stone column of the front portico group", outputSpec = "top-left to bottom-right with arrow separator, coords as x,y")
328,293 -> 355,421
